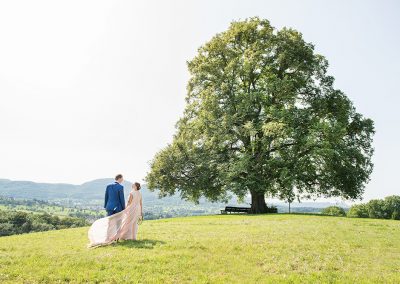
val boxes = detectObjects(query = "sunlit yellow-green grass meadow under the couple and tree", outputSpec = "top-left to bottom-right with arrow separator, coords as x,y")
0,214 -> 400,283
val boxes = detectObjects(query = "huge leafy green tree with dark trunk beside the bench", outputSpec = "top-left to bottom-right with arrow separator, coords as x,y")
146,18 -> 374,213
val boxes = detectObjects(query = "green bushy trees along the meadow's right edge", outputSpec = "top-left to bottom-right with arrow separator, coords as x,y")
322,195 -> 400,220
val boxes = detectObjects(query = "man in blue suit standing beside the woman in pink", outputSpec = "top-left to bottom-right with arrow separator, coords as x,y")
104,175 -> 125,216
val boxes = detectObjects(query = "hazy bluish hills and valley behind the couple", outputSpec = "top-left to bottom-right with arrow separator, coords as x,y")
0,178 -> 248,219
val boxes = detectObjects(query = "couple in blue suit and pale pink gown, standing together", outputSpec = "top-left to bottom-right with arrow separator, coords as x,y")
88,174 -> 143,247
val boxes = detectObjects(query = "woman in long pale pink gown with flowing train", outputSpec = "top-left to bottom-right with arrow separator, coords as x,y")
88,182 -> 143,247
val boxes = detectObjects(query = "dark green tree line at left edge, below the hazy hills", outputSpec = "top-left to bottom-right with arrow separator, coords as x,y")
0,210 -> 89,236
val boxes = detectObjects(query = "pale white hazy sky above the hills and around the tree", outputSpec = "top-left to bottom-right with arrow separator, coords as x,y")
0,0 -> 400,199
